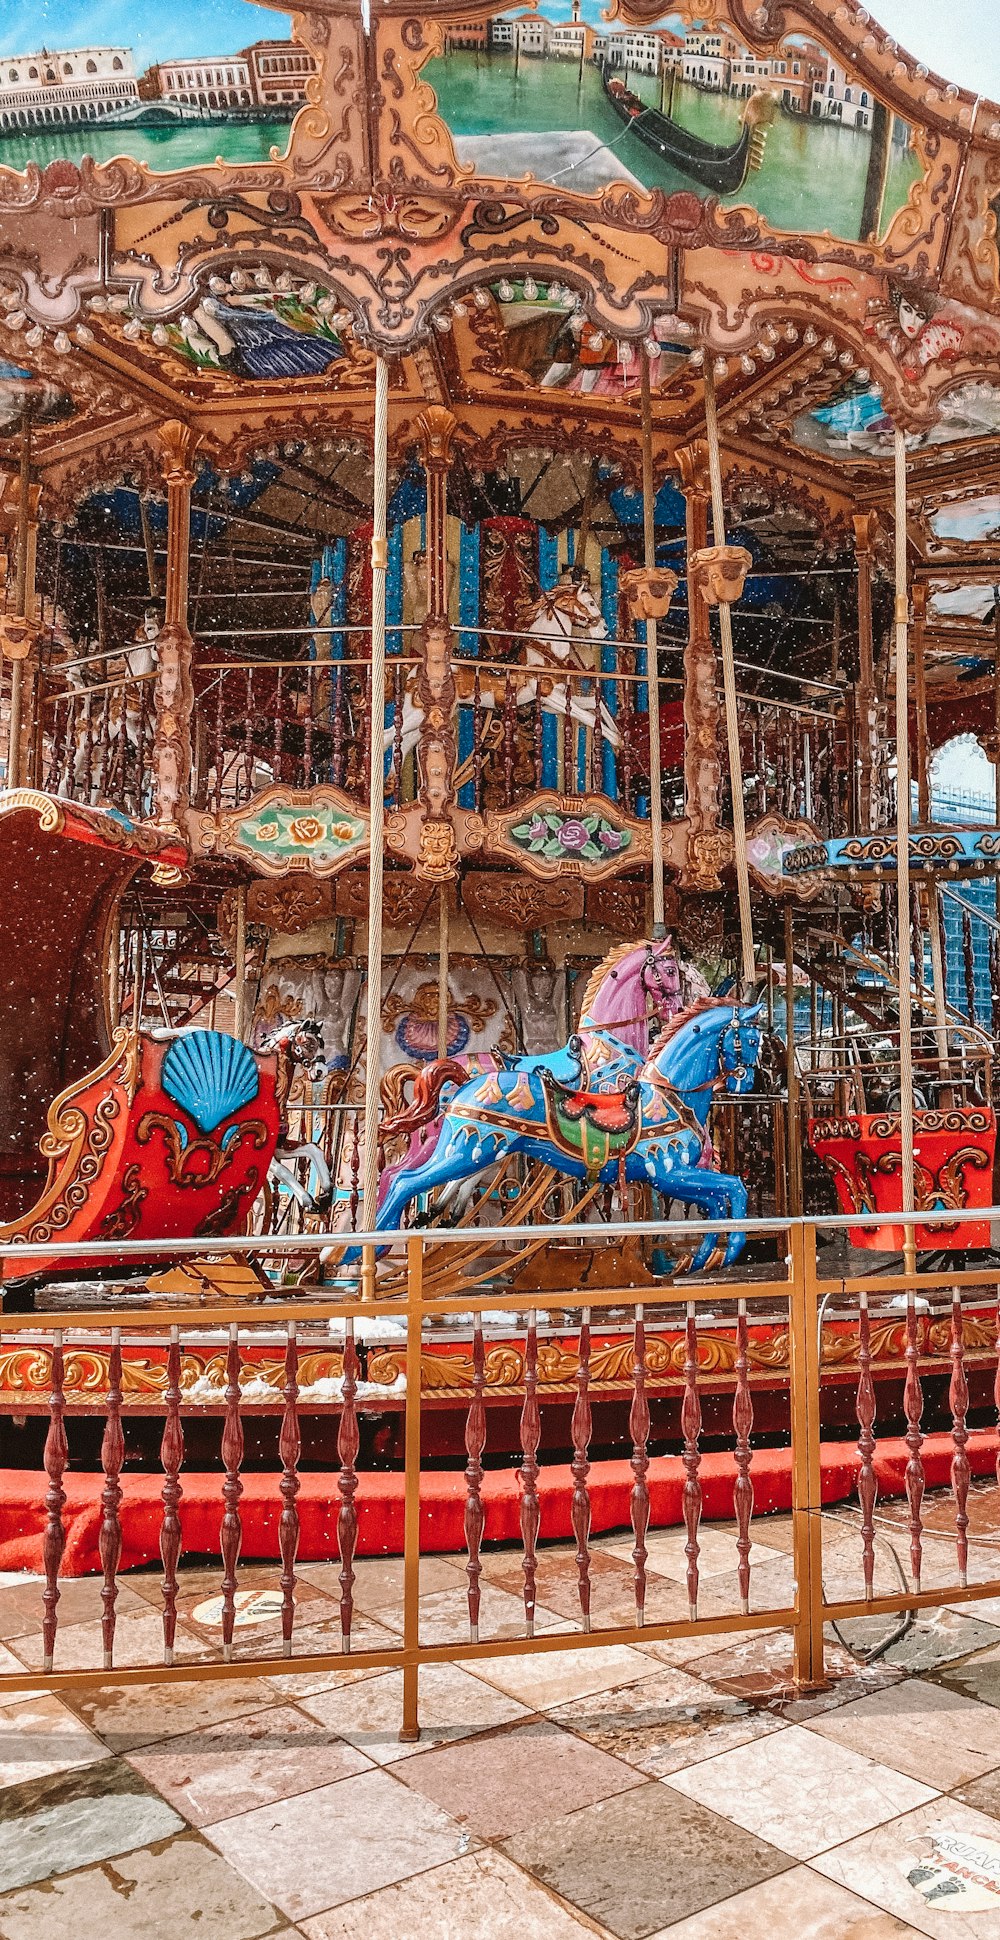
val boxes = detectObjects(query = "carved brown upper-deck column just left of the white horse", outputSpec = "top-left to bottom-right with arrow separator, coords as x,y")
416,417 -> 458,883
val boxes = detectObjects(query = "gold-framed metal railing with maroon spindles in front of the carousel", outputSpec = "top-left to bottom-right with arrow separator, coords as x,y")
0,1209 -> 1000,1738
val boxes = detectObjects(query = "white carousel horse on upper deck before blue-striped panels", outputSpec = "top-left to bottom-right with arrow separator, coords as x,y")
384,572 -> 621,760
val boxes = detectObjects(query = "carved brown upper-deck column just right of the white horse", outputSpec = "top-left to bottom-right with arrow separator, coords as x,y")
676,438 -> 728,890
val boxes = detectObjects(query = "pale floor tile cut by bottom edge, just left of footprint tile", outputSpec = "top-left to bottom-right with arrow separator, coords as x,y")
654,1866 -> 918,1940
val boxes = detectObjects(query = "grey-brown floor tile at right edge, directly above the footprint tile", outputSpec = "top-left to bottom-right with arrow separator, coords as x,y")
810,1678 -> 1000,1793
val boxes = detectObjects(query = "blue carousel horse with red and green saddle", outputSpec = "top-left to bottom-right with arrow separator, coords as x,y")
363,997 -> 761,1273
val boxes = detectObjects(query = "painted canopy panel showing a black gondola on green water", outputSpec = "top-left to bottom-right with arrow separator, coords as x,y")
423,0 -> 922,241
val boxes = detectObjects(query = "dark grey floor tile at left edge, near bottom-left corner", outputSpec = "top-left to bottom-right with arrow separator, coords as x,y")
0,1758 -> 184,1893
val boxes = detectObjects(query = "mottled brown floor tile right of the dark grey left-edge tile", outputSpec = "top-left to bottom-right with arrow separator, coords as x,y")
130,1705 -> 371,1826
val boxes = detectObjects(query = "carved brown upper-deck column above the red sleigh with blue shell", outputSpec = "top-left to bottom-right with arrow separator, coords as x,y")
153,417 -> 198,834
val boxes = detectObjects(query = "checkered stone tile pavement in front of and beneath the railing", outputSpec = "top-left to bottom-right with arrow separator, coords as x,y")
0,1519 -> 1000,1940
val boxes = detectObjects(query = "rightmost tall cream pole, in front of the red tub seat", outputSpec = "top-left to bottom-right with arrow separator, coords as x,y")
893,425 -> 917,1273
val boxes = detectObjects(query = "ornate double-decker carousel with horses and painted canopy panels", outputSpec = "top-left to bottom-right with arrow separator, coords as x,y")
0,0 -> 1000,1467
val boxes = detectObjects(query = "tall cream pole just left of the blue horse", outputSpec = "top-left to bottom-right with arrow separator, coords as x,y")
361,357 -> 388,1300
